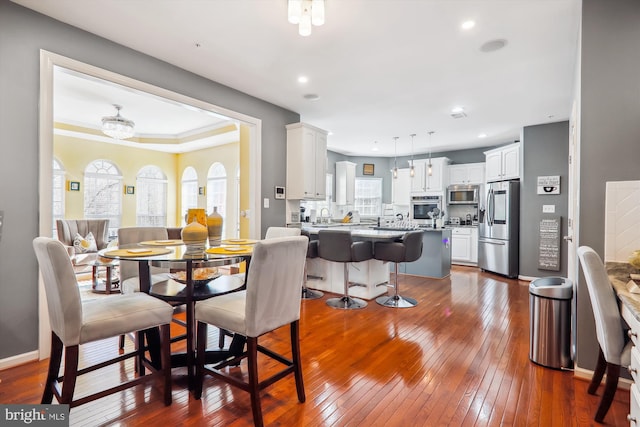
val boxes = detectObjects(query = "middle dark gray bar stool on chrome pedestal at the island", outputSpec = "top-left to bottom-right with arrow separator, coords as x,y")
318,230 -> 373,310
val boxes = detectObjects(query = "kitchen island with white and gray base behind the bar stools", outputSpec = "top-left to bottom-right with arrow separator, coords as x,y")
303,224 -> 451,300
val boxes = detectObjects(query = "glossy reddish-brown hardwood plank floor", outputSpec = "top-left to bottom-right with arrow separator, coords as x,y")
0,267 -> 629,426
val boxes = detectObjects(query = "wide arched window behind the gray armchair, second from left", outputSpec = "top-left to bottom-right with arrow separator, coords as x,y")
84,160 -> 122,237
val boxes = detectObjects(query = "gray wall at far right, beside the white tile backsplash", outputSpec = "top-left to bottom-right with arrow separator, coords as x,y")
577,0 -> 640,369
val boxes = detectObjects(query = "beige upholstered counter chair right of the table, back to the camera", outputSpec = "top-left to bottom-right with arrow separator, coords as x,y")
194,236 -> 308,426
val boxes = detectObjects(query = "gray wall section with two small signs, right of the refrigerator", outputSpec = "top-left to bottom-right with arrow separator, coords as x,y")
520,122 -> 569,277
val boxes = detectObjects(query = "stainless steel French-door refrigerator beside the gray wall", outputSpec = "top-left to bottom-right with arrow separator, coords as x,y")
478,181 -> 520,278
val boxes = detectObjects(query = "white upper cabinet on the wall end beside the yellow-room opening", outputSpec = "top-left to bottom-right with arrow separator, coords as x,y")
286,123 -> 327,200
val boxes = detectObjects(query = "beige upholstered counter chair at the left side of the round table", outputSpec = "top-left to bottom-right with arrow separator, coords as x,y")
33,237 -> 173,408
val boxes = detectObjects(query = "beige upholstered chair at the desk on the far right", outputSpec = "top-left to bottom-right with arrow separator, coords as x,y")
578,246 -> 632,423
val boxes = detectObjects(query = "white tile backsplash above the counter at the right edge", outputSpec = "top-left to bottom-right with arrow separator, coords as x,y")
604,181 -> 640,262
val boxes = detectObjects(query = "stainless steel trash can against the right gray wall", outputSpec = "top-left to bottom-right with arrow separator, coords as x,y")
529,277 -> 573,369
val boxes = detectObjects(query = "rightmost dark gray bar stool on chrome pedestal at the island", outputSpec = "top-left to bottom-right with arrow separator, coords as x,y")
373,230 -> 424,308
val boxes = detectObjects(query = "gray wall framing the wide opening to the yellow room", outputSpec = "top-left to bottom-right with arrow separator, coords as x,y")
0,0 -> 300,359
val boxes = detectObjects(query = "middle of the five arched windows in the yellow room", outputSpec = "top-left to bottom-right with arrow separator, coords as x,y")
136,166 -> 167,227
